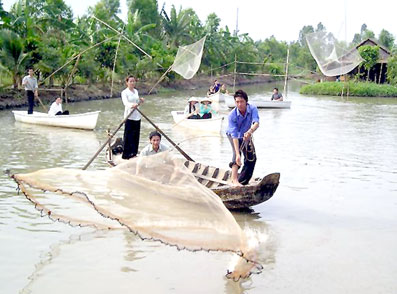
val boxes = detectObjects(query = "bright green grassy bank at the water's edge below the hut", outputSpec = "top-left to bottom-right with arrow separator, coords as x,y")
300,82 -> 397,97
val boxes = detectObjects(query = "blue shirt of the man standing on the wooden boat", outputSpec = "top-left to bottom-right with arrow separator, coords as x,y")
226,103 -> 259,138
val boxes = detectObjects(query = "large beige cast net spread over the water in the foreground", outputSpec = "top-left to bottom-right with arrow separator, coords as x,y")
13,152 -> 261,280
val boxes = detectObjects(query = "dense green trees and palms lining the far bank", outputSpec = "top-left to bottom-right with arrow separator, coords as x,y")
0,0 -> 394,87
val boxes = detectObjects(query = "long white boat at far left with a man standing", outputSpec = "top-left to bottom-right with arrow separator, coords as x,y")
12,110 -> 100,130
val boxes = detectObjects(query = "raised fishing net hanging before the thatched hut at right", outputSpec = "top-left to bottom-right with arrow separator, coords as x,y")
306,31 -> 363,76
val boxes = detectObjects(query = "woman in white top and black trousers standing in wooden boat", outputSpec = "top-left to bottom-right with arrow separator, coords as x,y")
121,75 -> 144,159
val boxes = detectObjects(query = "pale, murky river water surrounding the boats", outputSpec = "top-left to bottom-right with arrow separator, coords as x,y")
0,84 -> 397,294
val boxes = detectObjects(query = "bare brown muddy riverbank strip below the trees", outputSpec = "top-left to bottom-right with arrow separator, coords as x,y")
0,75 -> 275,110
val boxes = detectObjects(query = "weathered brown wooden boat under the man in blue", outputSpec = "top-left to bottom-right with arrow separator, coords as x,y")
106,138 -> 280,210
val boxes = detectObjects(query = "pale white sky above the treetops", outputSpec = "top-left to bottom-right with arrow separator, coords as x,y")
2,0 -> 397,42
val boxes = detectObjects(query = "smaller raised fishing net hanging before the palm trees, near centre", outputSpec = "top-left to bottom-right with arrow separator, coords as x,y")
172,37 -> 206,79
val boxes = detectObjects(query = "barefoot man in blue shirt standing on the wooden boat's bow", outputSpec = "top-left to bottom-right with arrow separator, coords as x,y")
226,90 -> 259,186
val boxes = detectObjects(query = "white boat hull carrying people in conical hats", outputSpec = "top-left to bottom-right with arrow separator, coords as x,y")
171,111 -> 224,133
